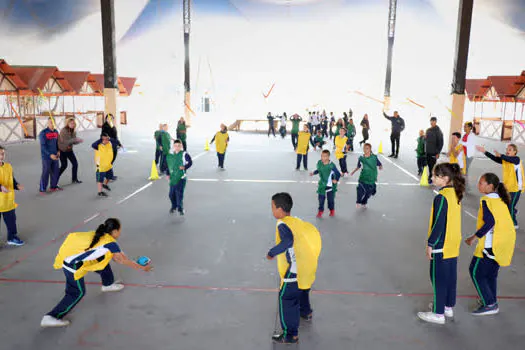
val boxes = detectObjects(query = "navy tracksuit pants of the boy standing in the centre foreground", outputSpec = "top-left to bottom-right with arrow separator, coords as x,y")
279,282 -> 312,339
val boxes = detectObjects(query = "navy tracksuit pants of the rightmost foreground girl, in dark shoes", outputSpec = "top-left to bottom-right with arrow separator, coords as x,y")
469,256 -> 499,306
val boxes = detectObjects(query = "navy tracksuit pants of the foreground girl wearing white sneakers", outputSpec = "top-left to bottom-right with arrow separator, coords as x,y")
430,253 -> 458,315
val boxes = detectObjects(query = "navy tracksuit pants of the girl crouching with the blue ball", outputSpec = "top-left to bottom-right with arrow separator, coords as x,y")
48,264 -> 115,319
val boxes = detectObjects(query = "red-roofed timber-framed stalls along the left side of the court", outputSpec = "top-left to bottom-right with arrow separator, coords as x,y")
0,59 -> 136,142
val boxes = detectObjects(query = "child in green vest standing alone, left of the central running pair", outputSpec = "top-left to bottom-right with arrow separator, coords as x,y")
167,140 -> 193,215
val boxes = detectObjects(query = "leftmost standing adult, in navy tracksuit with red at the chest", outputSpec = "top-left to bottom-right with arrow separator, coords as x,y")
38,118 -> 62,193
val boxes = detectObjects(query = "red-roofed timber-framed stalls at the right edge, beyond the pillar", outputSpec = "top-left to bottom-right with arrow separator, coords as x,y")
466,71 -> 525,143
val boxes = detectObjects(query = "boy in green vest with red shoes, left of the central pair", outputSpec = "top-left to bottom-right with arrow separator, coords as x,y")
310,149 -> 341,218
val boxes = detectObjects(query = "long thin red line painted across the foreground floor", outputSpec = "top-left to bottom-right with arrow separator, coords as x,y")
0,278 -> 525,301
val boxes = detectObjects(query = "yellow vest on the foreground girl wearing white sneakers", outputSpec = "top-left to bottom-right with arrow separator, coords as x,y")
427,187 -> 461,259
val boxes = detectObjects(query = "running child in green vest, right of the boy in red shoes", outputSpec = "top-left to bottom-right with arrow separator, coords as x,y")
350,143 -> 383,209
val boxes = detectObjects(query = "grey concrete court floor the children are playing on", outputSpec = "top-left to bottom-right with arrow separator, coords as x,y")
0,129 -> 525,350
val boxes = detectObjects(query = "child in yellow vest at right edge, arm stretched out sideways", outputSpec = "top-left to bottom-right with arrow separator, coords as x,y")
476,143 -> 525,229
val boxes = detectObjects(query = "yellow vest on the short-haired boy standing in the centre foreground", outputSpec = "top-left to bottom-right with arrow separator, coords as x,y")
275,216 -> 322,289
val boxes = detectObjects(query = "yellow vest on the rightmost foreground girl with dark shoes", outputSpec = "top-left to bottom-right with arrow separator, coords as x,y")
474,196 -> 516,266
